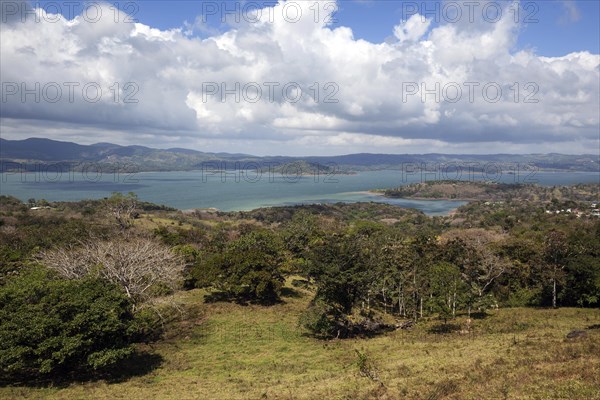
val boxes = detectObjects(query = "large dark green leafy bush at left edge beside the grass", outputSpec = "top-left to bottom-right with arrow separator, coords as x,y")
0,268 -> 149,380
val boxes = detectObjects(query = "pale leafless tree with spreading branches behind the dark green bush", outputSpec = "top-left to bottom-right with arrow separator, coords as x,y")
40,237 -> 185,308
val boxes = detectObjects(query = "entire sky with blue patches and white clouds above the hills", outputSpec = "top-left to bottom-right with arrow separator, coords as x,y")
0,0 -> 600,156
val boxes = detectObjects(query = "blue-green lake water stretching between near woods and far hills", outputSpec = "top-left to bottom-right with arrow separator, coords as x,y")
0,170 -> 600,215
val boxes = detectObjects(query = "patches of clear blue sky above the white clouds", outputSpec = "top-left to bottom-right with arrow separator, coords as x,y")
34,0 -> 600,56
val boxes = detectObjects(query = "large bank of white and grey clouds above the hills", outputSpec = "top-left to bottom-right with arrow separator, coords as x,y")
0,1 -> 600,154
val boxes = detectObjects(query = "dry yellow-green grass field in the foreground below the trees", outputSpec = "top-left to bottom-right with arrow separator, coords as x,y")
0,282 -> 600,400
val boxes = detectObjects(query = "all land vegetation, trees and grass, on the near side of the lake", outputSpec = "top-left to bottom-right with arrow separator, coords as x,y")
0,183 -> 600,399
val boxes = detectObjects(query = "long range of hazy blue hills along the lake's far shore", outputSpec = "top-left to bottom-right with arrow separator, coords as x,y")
0,138 -> 600,172
